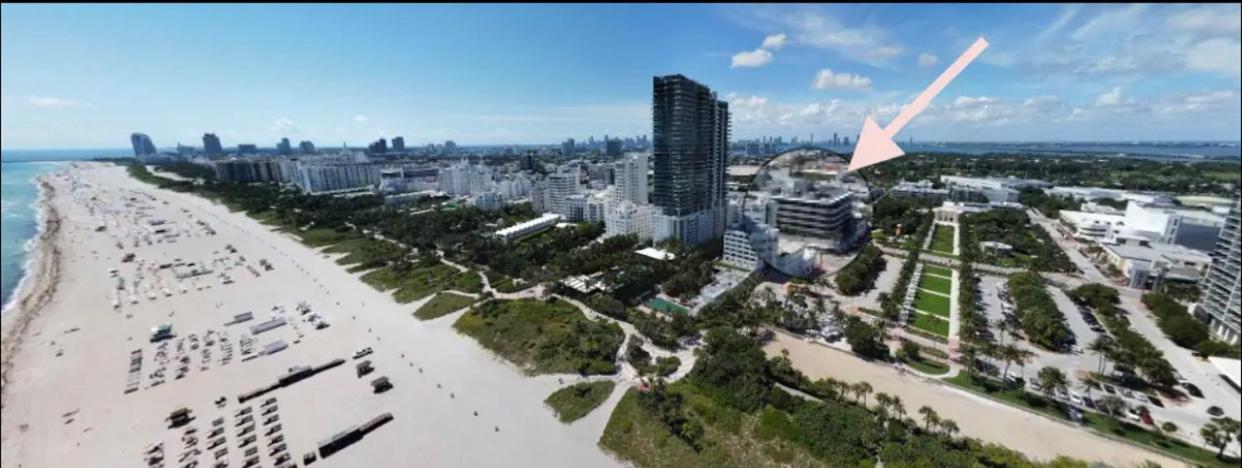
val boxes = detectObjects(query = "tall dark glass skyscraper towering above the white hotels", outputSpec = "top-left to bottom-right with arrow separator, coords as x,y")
651,74 -> 729,245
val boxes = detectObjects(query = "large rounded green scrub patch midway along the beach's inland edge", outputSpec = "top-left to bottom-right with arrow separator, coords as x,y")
453,299 -> 625,375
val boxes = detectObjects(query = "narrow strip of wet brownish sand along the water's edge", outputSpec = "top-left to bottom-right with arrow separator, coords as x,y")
0,171 -> 61,407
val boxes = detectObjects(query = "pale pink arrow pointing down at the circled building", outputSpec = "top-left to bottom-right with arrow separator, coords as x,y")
848,37 -> 987,171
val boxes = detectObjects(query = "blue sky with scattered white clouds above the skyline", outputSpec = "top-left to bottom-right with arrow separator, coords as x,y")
0,4 -> 1242,149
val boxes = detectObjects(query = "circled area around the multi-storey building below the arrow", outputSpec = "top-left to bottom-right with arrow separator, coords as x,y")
724,148 -> 871,278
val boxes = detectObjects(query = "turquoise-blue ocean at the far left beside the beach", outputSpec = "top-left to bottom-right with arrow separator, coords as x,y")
0,149 -> 128,309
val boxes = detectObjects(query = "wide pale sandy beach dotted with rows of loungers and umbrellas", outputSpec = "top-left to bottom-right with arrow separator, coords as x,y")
0,164 -> 626,467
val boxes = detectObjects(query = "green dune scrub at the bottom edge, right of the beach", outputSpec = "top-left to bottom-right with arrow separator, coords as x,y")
600,382 -> 826,468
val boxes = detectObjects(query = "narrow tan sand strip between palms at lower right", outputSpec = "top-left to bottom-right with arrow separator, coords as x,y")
764,333 -> 1185,467
